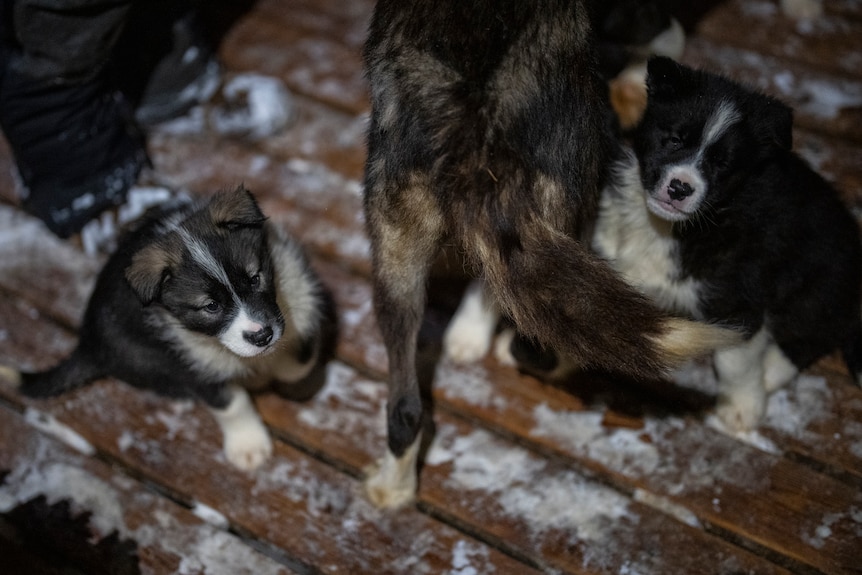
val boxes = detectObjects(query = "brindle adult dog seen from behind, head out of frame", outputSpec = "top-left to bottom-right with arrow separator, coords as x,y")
364,0 -> 729,507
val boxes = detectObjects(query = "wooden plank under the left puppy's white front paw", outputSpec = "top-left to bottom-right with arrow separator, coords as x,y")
0,314 -> 533,574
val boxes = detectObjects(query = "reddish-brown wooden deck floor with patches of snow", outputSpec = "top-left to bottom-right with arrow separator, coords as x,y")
0,0 -> 862,575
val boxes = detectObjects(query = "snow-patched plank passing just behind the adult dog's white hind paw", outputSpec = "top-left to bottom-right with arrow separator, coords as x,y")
259,362 -> 796,574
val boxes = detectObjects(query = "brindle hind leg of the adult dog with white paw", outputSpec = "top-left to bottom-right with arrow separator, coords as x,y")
365,182 -> 443,507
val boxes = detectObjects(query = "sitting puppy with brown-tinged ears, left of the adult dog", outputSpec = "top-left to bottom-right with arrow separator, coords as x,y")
20,188 -> 334,470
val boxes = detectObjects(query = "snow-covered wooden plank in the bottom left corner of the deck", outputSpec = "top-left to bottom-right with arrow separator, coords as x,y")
0,400 -> 293,575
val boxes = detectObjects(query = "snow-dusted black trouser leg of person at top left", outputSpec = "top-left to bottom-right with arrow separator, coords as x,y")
0,0 -> 147,237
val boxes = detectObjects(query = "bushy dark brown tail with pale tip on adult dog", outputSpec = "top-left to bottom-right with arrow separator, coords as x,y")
477,231 -> 741,379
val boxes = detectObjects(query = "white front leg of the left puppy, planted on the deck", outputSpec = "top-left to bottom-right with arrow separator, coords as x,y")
205,385 -> 272,471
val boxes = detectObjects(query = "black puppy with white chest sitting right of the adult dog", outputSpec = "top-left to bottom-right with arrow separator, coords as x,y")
594,58 -> 862,430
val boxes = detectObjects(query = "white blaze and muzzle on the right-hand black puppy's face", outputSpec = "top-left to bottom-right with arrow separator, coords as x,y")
647,101 -> 740,221
